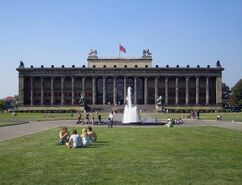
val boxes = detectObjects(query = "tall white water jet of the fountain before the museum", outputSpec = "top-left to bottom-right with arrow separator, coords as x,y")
122,87 -> 139,124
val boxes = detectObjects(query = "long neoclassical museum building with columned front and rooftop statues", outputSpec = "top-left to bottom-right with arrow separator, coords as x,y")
17,50 -> 224,110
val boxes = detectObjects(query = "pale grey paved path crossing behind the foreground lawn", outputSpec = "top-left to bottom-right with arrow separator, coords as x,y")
0,120 -> 242,142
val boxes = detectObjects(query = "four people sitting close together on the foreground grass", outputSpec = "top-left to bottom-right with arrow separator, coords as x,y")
58,126 -> 97,148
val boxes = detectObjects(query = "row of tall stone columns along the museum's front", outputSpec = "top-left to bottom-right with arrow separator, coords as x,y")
19,76 -> 222,105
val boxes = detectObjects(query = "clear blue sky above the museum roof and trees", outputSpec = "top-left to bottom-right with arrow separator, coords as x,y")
0,0 -> 242,98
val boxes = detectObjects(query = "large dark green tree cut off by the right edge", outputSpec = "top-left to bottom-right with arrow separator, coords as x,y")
229,79 -> 242,106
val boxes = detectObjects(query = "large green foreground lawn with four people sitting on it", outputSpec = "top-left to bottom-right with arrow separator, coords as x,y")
0,127 -> 242,185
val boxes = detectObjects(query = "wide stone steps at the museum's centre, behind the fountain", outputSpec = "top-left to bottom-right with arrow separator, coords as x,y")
85,105 -> 155,112
